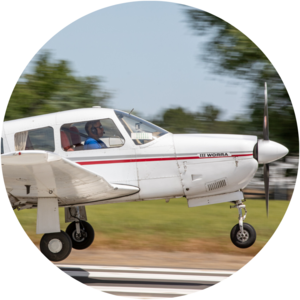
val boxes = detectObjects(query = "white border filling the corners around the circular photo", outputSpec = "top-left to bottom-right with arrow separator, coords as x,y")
0,0 -> 300,300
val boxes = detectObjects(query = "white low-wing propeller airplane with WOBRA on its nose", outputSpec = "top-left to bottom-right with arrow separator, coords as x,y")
1,83 -> 288,261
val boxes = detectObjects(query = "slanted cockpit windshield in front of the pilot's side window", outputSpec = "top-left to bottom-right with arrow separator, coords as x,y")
115,110 -> 168,145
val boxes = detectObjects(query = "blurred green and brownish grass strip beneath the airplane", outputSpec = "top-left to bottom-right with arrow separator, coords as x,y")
16,198 -> 289,255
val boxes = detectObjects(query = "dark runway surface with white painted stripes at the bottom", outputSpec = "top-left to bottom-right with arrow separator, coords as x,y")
57,264 -> 235,299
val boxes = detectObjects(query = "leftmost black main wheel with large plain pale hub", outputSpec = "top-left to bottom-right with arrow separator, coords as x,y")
40,231 -> 72,261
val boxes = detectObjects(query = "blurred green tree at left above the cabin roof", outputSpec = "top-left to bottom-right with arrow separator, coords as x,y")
5,52 -> 110,121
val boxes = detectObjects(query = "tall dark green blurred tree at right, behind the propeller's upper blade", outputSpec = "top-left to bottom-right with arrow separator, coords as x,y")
184,8 -> 299,154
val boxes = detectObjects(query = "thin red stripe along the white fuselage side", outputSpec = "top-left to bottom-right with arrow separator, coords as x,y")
77,154 -> 252,166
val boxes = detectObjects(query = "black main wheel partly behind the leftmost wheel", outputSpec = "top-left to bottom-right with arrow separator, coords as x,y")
66,221 -> 95,250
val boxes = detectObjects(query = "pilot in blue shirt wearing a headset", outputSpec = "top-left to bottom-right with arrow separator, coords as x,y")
84,120 -> 107,150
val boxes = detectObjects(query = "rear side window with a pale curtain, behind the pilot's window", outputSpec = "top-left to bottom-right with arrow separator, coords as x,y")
15,127 -> 55,152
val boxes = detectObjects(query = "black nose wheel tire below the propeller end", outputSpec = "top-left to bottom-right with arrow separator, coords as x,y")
230,223 -> 256,248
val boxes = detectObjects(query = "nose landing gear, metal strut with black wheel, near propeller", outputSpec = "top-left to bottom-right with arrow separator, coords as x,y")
230,200 -> 256,248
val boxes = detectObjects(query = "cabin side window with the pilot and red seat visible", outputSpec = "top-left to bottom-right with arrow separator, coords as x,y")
60,119 -> 125,151
